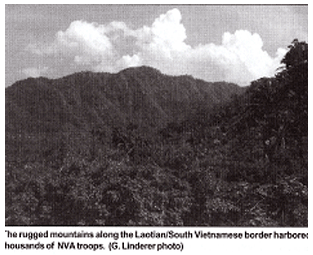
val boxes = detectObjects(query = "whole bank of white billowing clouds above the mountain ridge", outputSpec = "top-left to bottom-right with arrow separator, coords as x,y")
27,8 -> 286,85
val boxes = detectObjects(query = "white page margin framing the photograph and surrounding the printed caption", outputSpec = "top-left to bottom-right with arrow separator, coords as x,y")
0,0 -> 313,255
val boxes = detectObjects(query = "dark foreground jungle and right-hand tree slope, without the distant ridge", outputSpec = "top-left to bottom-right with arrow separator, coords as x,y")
5,40 -> 308,227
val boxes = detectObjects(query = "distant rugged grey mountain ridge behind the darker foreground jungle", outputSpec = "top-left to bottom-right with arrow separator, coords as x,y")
5,67 -> 243,133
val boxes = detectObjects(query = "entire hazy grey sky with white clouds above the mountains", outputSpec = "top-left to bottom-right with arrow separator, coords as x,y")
5,5 -> 308,86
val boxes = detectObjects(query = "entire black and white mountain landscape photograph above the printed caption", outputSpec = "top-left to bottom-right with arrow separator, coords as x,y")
5,4 -> 308,229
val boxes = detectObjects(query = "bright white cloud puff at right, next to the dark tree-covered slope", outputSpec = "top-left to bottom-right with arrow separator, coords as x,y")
184,30 -> 286,85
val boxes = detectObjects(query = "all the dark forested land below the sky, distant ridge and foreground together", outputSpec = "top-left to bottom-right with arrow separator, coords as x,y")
5,40 -> 308,226
